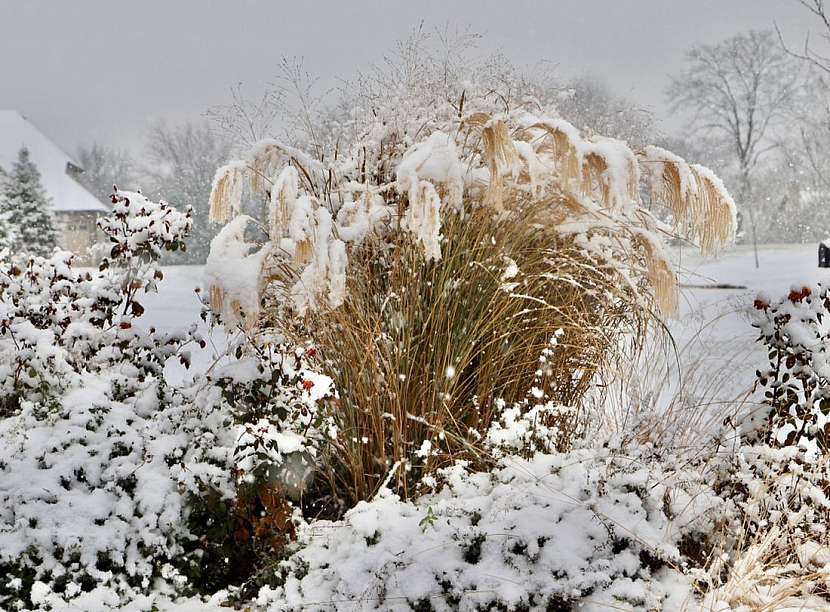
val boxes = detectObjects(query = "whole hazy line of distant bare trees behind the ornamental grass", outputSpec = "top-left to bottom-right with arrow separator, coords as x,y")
76,5 -> 830,263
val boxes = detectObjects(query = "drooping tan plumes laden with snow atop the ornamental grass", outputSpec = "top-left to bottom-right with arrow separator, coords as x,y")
211,100 -> 735,322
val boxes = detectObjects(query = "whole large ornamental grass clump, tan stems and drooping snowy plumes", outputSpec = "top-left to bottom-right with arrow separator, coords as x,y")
208,69 -> 735,505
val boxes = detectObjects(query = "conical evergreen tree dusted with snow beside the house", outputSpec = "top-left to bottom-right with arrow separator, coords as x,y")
0,147 -> 58,256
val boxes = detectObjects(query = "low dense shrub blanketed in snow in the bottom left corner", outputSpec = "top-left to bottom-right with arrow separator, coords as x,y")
0,372 -> 197,609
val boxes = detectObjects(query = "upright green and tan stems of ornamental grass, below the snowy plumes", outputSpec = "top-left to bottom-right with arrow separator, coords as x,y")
307,209 -> 648,500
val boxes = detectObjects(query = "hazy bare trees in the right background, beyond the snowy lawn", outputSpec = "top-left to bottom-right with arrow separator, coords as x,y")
668,11 -> 830,265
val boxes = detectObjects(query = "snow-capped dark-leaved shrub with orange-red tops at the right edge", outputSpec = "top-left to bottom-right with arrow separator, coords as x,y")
753,285 -> 830,459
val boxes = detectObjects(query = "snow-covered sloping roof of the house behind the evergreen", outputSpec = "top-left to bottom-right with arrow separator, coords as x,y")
0,110 -> 109,212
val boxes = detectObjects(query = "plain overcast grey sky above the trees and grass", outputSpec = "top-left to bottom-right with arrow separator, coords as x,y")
0,0 -> 817,151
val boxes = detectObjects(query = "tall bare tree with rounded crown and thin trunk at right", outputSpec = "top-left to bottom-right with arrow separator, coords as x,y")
669,31 -> 801,267
